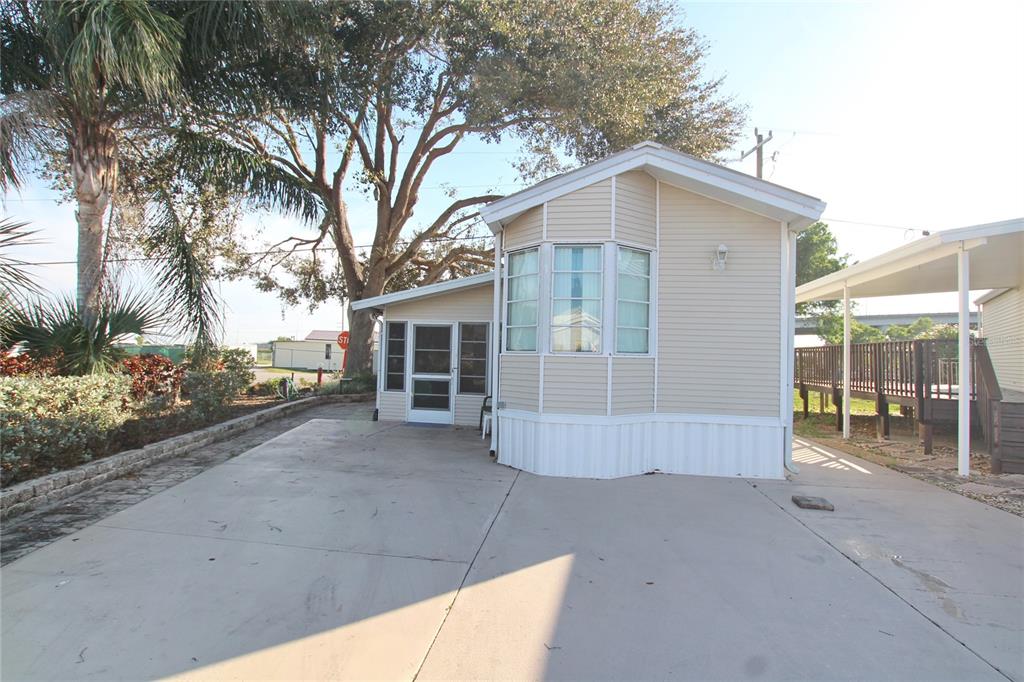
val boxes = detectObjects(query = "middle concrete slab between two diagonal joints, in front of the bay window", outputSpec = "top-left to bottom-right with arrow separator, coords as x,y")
420,474 -> 1004,680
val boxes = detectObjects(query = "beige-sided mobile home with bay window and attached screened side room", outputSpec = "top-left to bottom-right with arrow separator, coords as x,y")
352,142 -> 824,478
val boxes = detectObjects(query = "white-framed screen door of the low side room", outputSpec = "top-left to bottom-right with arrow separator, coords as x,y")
409,325 -> 455,424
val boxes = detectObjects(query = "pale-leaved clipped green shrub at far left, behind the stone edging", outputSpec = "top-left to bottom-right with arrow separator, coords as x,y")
0,374 -> 132,485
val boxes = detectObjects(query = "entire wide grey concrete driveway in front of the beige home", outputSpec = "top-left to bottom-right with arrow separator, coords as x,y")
2,419 -> 1024,680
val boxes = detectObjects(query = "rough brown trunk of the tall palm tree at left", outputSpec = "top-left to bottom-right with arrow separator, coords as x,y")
69,122 -> 118,324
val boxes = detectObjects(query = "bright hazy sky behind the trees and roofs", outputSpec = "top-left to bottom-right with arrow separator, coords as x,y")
3,2 -> 1024,343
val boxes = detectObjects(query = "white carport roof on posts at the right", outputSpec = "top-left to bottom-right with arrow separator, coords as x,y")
797,218 -> 1024,303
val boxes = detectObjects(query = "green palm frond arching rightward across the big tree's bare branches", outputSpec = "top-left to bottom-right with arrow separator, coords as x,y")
172,131 -> 323,223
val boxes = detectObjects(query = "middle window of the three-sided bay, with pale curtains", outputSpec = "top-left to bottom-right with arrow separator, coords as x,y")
551,246 -> 601,353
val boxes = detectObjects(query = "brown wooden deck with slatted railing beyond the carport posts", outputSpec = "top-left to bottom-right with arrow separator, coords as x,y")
794,339 -> 1024,472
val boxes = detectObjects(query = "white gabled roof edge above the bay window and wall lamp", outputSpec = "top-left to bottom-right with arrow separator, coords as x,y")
480,141 -> 825,235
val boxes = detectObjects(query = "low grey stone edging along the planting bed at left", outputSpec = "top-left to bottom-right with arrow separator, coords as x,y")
0,393 -> 373,520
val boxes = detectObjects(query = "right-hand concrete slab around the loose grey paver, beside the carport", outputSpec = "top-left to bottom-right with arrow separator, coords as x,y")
759,440 -> 1024,680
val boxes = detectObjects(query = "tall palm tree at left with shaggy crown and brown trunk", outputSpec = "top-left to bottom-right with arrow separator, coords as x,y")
0,0 -> 259,341
